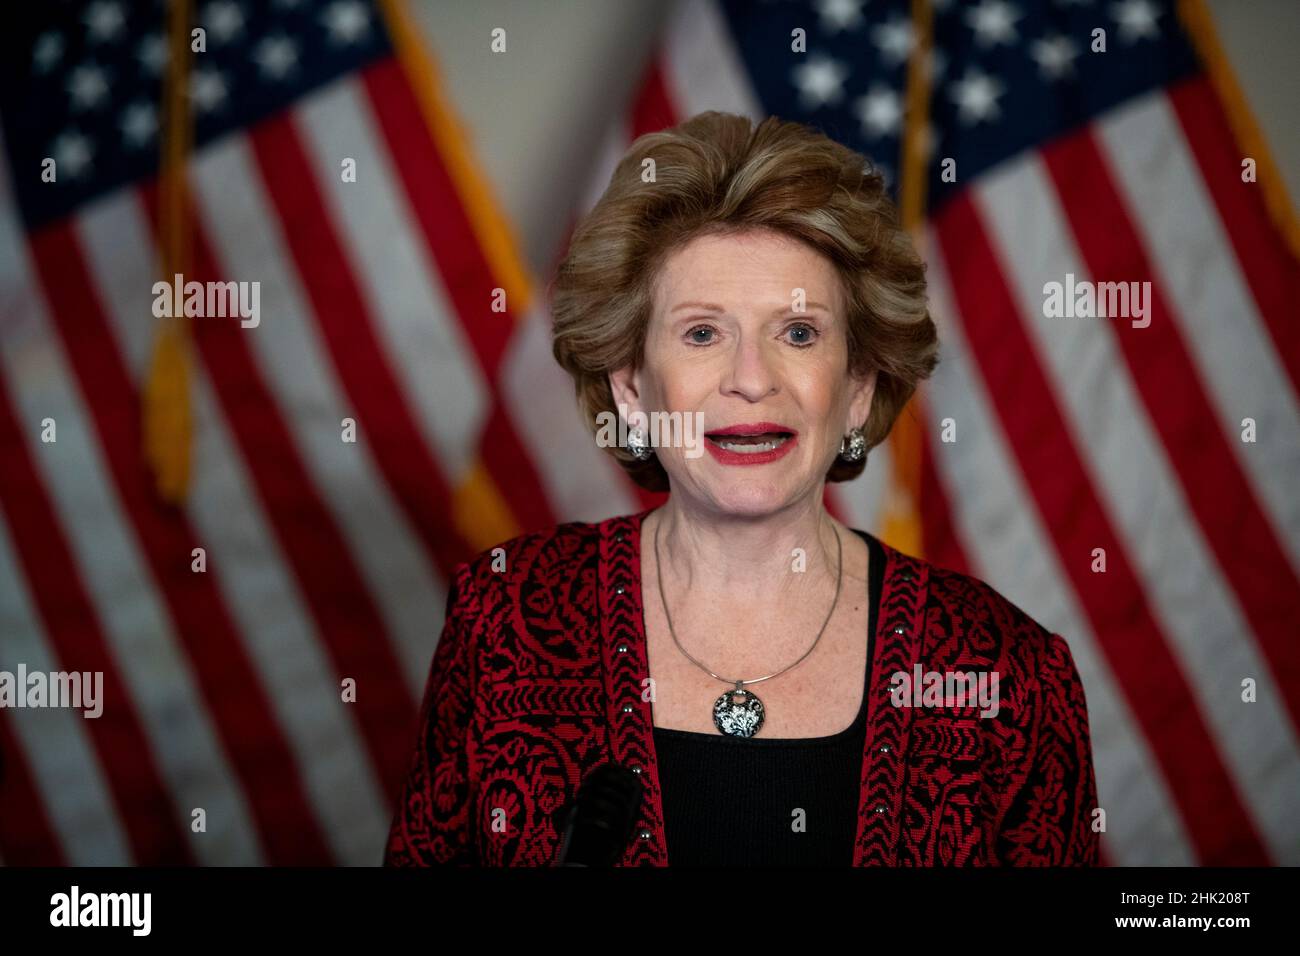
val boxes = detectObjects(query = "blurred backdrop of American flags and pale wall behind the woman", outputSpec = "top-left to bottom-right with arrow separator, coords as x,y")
0,0 -> 1300,865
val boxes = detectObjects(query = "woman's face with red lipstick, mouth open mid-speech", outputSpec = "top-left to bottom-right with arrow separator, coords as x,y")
610,230 -> 875,515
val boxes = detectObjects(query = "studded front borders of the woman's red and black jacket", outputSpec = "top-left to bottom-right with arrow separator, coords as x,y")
597,509 -> 930,866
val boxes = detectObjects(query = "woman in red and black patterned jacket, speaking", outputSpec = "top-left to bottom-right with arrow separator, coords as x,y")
385,113 -> 1097,866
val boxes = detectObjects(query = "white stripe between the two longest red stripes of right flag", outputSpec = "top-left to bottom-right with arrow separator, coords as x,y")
975,153 -> 1300,857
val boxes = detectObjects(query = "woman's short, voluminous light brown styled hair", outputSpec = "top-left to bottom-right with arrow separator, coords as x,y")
551,111 -> 939,492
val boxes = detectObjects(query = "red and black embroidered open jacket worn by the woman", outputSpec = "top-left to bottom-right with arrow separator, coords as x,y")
384,510 -> 1099,866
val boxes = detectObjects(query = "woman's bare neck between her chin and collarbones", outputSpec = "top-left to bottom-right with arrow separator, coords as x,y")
644,496 -> 850,600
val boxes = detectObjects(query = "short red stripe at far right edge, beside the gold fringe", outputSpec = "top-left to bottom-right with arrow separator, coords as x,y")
1167,77 -> 1300,392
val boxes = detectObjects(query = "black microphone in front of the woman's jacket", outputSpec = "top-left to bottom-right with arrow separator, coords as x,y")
555,763 -> 642,866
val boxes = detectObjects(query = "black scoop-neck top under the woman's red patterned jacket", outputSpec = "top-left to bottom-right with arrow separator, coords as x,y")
654,528 -> 885,866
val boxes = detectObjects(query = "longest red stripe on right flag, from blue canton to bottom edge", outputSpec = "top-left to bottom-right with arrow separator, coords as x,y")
936,194 -> 1268,865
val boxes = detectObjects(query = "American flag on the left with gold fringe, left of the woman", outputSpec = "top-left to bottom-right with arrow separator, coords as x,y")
0,0 -> 590,865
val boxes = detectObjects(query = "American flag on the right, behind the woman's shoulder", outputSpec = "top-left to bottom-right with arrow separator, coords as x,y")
598,0 -> 1300,865
